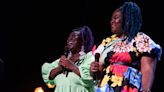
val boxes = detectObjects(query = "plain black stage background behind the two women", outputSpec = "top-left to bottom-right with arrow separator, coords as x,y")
0,0 -> 164,92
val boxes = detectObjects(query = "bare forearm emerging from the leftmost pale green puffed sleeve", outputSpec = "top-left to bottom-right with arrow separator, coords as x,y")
49,66 -> 62,80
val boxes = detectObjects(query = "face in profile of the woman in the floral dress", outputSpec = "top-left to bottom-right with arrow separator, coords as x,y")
110,9 -> 122,34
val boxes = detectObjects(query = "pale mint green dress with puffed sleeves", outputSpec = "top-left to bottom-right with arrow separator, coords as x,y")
41,52 -> 94,92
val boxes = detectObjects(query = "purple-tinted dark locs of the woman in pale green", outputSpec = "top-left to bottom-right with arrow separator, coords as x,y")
73,26 -> 94,53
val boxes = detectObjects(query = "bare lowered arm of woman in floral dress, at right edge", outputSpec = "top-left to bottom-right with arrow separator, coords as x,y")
141,56 -> 157,92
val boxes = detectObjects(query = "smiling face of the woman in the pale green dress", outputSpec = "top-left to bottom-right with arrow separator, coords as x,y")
67,32 -> 82,52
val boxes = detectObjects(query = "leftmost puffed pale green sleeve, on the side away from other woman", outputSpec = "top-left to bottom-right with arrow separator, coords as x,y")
41,59 -> 59,85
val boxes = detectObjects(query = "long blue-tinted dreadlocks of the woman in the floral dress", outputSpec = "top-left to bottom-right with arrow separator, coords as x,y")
119,2 -> 142,41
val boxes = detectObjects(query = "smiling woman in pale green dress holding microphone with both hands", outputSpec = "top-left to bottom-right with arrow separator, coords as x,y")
42,26 -> 94,92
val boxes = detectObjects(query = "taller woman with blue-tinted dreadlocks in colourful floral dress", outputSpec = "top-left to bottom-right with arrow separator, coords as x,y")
91,2 -> 162,92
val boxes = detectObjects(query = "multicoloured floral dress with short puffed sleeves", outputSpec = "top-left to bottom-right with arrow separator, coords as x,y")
95,32 -> 162,92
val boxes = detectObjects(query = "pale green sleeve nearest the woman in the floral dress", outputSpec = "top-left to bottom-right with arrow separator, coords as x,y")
79,52 -> 94,87
